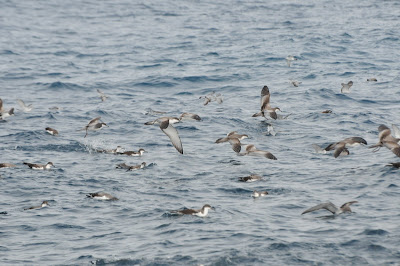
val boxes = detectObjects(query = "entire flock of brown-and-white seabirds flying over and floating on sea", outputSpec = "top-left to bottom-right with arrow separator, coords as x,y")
0,55 -> 400,217
